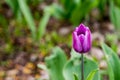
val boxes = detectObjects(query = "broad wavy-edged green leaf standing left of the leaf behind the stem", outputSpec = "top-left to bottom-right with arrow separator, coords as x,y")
45,47 -> 67,80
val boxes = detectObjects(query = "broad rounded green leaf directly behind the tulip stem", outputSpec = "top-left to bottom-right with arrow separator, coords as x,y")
63,51 -> 100,80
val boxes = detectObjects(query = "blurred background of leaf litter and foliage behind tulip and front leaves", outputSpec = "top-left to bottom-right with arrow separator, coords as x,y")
0,0 -> 120,80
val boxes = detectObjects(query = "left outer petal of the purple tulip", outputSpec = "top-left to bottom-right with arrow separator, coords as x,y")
73,31 -> 82,52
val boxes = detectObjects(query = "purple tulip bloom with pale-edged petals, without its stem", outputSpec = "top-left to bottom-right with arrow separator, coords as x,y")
73,24 -> 92,53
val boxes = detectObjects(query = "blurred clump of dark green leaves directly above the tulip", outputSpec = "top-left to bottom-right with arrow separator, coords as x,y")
55,0 -> 98,26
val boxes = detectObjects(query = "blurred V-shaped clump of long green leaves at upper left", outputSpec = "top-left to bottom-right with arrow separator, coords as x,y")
6,0 -> 51,40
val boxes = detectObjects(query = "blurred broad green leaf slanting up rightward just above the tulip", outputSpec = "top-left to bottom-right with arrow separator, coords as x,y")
70,0 -> 98,26
